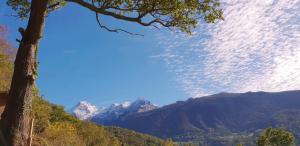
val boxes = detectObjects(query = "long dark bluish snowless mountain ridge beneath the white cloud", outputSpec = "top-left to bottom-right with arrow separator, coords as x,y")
109,91 -> 300,145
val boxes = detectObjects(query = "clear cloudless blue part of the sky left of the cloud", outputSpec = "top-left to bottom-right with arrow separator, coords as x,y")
0,1 -> 189,108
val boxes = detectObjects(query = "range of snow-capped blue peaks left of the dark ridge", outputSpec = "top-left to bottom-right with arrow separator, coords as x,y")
72,98 -> 158,124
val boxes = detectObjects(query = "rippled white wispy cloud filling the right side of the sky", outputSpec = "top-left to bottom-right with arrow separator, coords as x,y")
158,0 -> 300,97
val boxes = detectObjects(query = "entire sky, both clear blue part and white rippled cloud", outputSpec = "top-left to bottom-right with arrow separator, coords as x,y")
0,0 -> 300,109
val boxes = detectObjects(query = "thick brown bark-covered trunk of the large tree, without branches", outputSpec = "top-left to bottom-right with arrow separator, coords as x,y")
0,0 -> 48,146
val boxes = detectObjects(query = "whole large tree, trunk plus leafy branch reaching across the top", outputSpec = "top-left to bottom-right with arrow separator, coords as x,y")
0,0 -> 223,146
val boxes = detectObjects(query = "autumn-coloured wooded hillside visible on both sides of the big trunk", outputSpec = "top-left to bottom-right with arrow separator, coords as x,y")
0,25 -> 173,146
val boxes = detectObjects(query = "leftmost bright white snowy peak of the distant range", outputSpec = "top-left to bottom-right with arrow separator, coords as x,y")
72,101 -> 101,120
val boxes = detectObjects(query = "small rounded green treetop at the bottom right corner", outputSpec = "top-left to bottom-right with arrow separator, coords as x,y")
256,128 -> 295,146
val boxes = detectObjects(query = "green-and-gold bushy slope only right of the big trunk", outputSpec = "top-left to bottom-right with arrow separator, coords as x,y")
32,90 -> 173,146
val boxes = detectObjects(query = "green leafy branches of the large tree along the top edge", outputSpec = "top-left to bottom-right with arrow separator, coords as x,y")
7,0 -> 223,33
